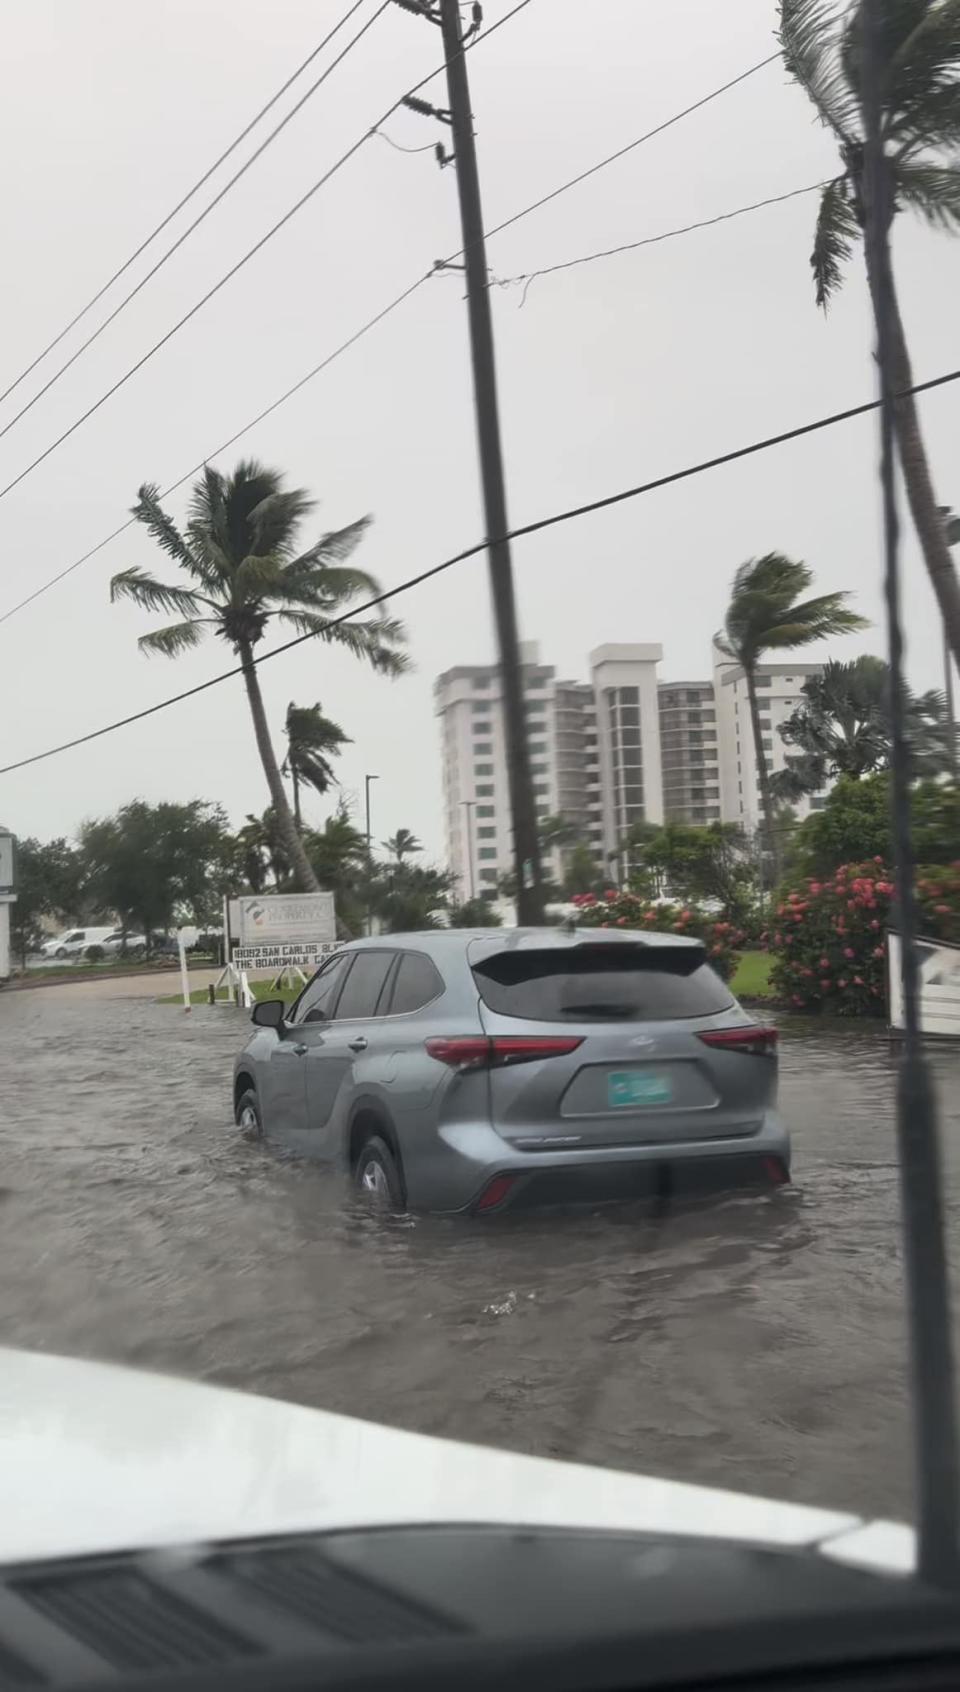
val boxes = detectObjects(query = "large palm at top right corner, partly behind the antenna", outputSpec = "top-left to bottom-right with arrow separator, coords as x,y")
779,0 -> 960,663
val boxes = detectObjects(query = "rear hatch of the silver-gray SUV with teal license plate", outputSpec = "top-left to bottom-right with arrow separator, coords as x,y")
471,936 -> 775,1152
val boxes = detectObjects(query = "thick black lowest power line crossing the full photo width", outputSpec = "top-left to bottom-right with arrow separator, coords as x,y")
0,369 -> 960,775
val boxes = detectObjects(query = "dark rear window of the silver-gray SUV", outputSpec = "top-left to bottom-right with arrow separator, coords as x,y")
474,946 -> 733,1022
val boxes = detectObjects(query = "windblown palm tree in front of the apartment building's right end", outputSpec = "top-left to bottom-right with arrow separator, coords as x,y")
716,552 -> 867,880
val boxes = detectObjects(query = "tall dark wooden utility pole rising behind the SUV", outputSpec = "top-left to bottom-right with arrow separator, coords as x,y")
433,0 -> 543,926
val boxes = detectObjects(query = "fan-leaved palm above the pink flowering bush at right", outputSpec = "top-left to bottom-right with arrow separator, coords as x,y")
770,655 -> 950,800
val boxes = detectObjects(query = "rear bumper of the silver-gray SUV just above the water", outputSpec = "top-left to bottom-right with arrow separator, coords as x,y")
405,1110 -> 791,1211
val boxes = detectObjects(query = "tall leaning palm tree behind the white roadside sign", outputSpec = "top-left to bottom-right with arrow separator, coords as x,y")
110,459 -> 406,892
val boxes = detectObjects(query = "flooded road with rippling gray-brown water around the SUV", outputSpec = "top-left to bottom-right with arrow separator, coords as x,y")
0,983 -> 960,1516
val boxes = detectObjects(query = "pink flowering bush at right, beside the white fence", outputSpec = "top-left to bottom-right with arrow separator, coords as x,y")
765,858 -> 960,1017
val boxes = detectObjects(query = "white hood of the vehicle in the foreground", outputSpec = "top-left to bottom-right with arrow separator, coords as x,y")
0,1349 -> 913,1572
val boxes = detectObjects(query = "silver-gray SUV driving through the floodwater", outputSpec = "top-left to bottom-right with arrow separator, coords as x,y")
234,929 -> 791,1213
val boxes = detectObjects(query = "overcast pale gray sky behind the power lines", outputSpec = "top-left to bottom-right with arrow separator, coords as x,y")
0,0 -> 960,853
